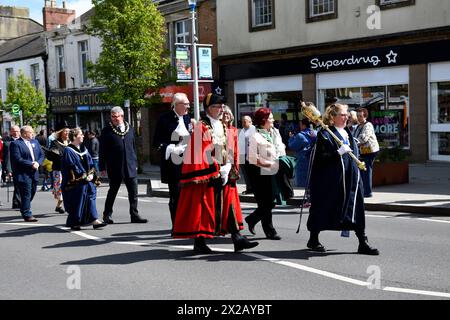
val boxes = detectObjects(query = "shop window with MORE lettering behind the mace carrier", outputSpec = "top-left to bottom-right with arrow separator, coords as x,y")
318,84 -> 409,148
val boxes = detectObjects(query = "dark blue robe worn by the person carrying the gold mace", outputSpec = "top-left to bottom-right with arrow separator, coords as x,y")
307,127 -> 365,232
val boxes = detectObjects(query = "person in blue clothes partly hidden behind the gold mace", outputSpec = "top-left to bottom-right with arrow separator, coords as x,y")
288,118 -> 316,188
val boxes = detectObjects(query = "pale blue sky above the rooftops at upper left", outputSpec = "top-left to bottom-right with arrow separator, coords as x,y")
0,0 -> 92,24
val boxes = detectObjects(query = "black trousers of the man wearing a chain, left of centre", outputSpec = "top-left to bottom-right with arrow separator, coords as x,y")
103,177 -> 138,217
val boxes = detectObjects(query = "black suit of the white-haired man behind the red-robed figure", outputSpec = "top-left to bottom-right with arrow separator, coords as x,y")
153,110 -> 192,226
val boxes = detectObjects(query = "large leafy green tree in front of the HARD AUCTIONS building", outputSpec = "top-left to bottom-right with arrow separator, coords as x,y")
87,0 -> 169,127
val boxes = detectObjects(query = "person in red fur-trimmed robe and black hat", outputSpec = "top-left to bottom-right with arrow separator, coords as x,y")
173,93 -> 258,254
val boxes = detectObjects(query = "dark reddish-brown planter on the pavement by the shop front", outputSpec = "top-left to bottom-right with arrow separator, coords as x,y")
372,160 -> 409,187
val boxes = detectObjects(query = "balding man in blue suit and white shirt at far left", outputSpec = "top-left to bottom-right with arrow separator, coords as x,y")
10,126 -> 44,222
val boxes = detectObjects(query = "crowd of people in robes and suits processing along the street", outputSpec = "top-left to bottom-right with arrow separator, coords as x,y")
0,93 -> 379,255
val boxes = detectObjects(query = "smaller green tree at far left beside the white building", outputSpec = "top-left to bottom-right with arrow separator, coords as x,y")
3,70 -> 47,127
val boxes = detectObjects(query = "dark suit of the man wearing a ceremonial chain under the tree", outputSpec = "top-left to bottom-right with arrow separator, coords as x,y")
99,124 -> 138,218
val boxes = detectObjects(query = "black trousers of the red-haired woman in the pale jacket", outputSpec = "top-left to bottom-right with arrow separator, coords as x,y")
246,164 -> 276,236
